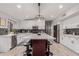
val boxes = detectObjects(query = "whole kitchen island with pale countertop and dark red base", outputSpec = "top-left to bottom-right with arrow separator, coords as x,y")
23,33 -> 55,56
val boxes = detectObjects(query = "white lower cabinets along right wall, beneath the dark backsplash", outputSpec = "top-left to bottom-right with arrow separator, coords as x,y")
61,37 -> 79,54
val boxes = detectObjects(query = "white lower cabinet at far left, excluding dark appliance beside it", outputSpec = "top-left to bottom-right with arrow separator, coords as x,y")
0,35 -> 11,52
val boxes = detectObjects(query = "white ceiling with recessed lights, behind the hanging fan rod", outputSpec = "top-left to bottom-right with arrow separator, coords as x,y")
0,3 -> 78,20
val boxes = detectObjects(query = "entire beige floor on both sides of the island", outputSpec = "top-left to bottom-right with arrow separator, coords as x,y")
0,42 -> 79,56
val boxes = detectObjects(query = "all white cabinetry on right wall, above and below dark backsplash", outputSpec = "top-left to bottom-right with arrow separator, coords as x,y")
60,15 -> 79,54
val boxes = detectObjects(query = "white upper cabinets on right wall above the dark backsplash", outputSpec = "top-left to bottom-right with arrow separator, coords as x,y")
62,15 -> 79,29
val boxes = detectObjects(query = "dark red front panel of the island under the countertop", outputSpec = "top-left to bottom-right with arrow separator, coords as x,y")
32,39 -> 46,56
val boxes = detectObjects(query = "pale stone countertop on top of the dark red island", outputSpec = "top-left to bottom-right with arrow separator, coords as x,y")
23,33 -> 55,43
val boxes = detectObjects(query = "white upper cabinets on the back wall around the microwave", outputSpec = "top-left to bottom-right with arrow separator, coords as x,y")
19,20 -> 45,29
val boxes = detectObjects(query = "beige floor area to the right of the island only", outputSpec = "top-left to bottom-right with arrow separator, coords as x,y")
50,42 -> 78,56
